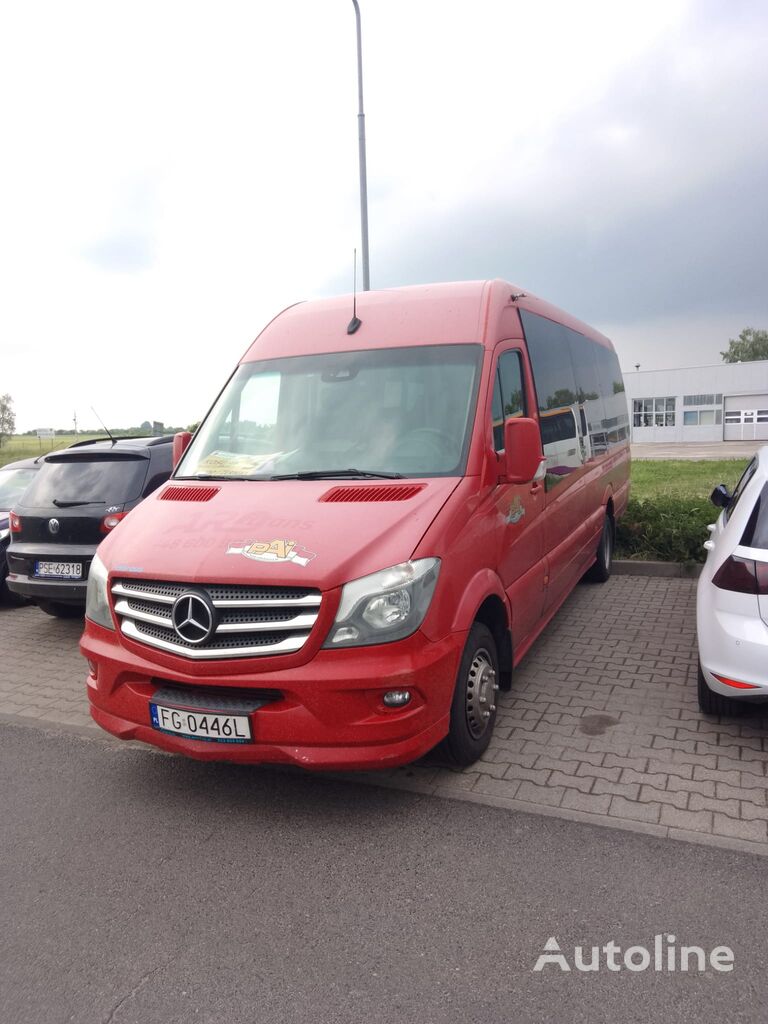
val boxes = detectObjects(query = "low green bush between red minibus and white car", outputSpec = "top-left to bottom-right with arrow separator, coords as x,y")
616,495 -> 720,562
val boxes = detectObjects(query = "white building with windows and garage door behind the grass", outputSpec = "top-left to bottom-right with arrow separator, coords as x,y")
624,359 -> 768,442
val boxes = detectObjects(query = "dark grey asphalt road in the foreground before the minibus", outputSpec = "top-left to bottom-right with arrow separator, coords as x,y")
0,725 -> 768,1024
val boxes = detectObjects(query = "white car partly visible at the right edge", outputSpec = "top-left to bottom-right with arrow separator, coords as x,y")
696,446 -> 768,715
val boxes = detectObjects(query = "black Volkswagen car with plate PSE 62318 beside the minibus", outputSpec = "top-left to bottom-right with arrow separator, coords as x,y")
8,436 -> 173,616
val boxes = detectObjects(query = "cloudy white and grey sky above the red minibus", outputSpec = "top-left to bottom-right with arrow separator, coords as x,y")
0,0 -> 768,430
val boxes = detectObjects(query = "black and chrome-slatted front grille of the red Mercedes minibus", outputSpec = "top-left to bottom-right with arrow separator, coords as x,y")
112,580 -> 322,658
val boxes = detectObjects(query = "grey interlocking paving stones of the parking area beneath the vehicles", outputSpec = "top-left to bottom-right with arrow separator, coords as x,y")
0,575 -> 768,855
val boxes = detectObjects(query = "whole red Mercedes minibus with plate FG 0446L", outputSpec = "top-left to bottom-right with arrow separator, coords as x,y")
81,281 -> 630,769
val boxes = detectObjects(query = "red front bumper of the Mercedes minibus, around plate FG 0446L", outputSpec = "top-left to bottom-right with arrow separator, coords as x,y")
80,620 -> 466,770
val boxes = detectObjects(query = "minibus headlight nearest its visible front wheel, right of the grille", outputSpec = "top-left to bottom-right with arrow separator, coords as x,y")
324,558 -> 440,647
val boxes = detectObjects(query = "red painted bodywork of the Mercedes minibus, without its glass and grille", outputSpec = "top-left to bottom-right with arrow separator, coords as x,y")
81,281 -> 629,769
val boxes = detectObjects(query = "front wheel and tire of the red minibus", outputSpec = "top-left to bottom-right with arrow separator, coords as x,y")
443,623 -> 499,768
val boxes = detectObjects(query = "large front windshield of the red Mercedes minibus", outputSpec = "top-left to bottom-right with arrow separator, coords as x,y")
176,345 -> 482,479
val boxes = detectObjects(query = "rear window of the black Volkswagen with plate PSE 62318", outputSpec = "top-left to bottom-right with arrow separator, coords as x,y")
24,456 -> 150,508
